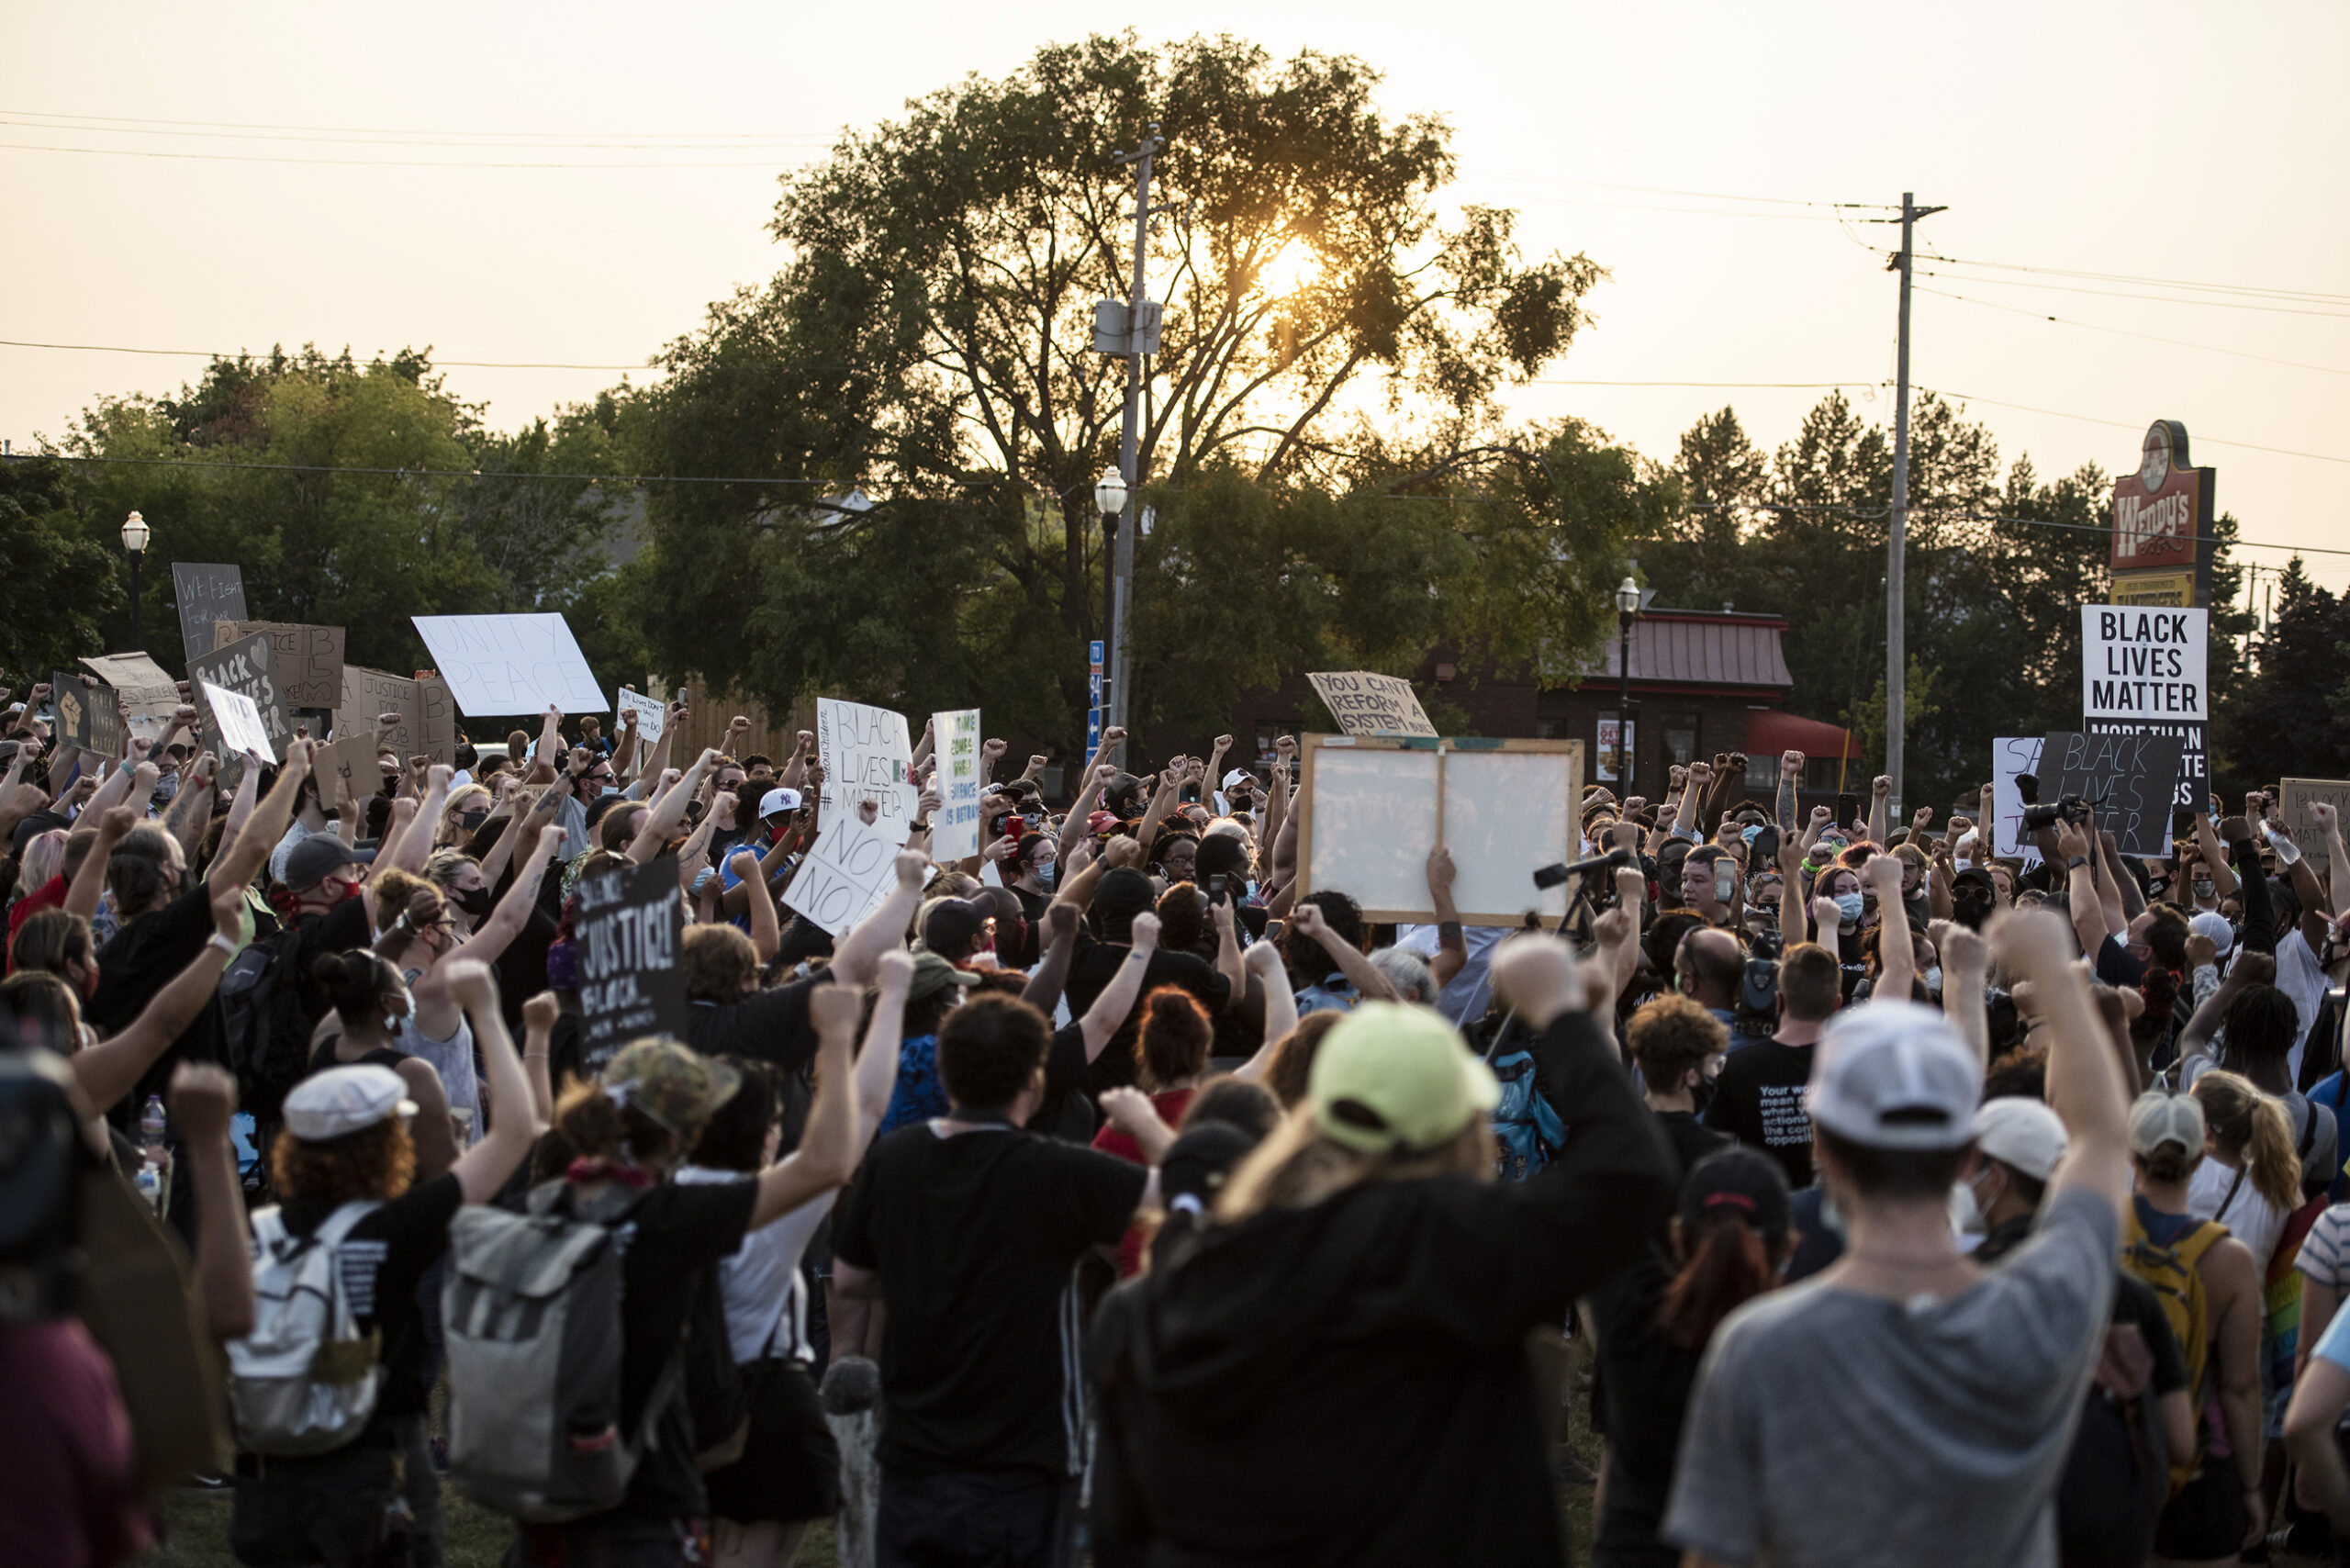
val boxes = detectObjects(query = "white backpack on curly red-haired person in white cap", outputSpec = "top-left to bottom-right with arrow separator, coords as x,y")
228,1202 -> 383,1455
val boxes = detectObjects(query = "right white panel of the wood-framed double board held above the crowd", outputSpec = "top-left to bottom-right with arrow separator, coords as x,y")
1445,752 -> 1582,924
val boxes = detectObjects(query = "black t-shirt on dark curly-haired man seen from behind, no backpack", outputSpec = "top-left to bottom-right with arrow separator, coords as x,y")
832,1121 -> 1149,1476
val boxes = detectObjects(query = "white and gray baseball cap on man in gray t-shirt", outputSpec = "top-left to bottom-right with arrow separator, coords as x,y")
1812,1002 -> 1984,1149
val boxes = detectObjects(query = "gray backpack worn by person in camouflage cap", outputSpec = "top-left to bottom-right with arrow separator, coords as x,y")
442,1180 -> 681,1523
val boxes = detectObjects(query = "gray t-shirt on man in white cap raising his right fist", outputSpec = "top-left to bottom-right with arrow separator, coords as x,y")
1662,1190 -> 2120,1568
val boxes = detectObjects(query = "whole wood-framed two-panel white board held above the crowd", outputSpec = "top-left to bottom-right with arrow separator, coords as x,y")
1297,736 -> 1583,926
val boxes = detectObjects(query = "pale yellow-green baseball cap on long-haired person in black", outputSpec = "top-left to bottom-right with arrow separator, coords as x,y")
1306,1002 -> 1502,1154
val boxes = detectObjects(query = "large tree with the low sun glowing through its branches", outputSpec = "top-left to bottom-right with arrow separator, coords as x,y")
643,35 -> 1612,736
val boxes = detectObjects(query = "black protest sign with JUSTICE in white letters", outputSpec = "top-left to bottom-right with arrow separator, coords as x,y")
571,856 -> 687,1072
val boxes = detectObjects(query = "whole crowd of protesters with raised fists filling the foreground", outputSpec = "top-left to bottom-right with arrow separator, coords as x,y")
0,687 -> 2350,1568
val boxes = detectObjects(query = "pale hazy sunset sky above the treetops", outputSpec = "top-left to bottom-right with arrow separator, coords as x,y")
0,0 -> 2350,609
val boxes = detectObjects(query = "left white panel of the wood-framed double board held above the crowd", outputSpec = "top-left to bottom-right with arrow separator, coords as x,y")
1306,736 -> 1438,913
